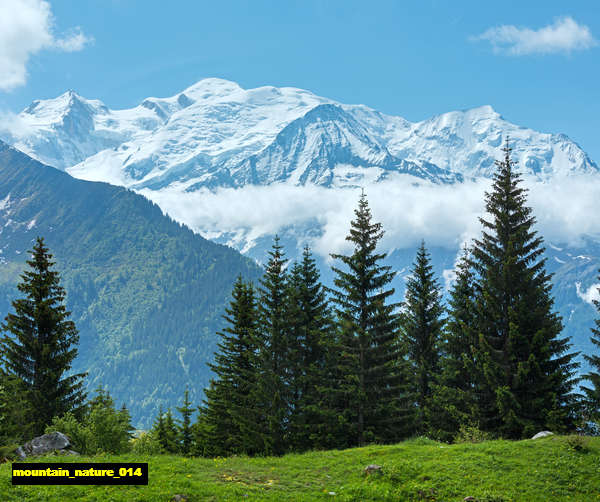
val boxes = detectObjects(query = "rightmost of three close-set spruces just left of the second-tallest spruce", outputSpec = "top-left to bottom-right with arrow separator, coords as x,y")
286,246 -> 333,451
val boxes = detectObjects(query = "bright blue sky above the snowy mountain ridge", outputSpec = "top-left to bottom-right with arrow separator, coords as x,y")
0,0 -> 600,163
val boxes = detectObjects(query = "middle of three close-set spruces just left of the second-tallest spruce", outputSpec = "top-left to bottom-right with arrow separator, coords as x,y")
255,236 -> 293,455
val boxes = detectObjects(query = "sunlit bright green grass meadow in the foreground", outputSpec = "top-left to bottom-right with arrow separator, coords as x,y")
0,436 -> 600,502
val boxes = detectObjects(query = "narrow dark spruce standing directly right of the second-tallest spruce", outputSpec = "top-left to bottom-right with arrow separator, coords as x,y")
401,241 -> 443,433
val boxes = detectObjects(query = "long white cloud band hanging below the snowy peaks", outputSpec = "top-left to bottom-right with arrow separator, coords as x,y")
141,175 -> 600,257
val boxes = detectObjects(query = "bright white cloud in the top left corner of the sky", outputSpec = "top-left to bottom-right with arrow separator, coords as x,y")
0,0 -> 91,91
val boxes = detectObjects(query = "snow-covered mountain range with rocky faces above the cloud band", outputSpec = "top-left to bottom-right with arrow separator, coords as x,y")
0,78 -> 598,191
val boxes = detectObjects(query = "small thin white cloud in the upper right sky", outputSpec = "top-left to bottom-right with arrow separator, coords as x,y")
474,17 -> 597,56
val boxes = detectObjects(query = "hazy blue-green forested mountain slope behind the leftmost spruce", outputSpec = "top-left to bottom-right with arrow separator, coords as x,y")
0,142 -> 261,427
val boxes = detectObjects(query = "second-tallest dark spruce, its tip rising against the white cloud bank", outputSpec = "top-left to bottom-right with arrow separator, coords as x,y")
329,192 -> 412,446
